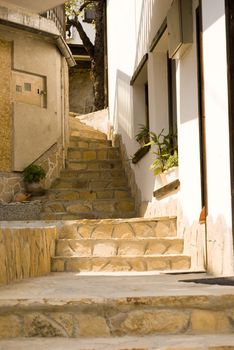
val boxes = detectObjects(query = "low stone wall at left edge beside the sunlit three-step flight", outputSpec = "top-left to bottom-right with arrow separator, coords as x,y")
0,224 -> 57,284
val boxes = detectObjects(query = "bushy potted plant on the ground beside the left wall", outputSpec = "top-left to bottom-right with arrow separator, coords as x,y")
23,164 -> 46,195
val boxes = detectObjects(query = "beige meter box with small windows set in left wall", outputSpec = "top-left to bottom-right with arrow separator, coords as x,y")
12,71 -> 47,108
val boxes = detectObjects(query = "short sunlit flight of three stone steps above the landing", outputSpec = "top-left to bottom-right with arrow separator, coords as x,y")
52,218 -> 190,272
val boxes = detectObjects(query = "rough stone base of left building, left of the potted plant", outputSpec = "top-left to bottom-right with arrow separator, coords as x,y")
0,173 -> 25,203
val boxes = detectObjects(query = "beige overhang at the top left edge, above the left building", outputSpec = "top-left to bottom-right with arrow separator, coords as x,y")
0,0 -> 65,13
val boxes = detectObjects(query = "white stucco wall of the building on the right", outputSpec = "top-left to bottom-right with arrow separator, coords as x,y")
107,0 -> 233,274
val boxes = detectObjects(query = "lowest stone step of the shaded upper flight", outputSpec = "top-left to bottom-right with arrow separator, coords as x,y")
43,198 -> 135,214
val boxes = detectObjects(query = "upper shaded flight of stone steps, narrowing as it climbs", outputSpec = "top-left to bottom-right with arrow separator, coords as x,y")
41,118 -> 136,220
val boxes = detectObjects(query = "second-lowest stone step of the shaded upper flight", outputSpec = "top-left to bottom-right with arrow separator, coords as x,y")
47,188 -> 131,201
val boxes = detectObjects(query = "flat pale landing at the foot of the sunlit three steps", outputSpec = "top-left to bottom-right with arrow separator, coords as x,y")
0,272 -> 234,300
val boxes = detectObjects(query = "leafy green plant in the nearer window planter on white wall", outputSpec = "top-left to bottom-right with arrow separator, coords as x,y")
145,129 -> 178,175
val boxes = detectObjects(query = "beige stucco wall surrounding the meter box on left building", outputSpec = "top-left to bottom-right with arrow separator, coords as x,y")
0,27 -> 62,171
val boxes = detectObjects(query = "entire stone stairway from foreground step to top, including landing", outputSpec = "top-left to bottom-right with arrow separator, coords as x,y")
0,120 -> 234,350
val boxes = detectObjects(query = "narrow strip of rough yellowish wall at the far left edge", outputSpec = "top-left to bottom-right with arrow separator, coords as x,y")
0,40 -> 12,171
